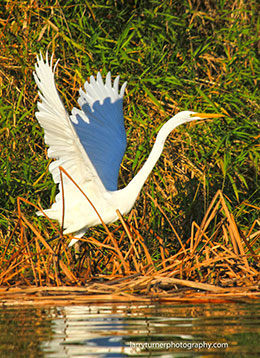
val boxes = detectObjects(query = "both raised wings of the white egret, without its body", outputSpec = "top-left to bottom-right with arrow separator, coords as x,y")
34,51 -> 126,194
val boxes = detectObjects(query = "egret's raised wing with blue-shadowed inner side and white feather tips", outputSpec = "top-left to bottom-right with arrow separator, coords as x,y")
71,72 -> 126,190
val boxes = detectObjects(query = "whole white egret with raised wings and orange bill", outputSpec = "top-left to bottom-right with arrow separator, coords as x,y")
34,53 -> 220,245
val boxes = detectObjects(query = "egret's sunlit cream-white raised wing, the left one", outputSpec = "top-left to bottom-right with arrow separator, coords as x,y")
34,54 -> 104,193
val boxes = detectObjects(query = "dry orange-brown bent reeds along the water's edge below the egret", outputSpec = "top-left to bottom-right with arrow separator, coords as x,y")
0,191 -> 260,304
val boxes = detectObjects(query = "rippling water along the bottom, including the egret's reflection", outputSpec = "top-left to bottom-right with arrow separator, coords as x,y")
0,302 -> 260,358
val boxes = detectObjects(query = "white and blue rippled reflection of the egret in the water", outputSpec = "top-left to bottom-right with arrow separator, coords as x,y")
42,304 -> 128,358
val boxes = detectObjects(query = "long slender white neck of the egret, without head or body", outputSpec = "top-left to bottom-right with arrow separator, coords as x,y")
124,118 -> 184,201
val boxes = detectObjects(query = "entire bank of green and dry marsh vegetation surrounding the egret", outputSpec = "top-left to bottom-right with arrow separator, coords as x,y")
0,0 -> 260,300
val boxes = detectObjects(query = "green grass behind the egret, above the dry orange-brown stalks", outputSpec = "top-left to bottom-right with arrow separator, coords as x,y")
0,0 -> 260,252
